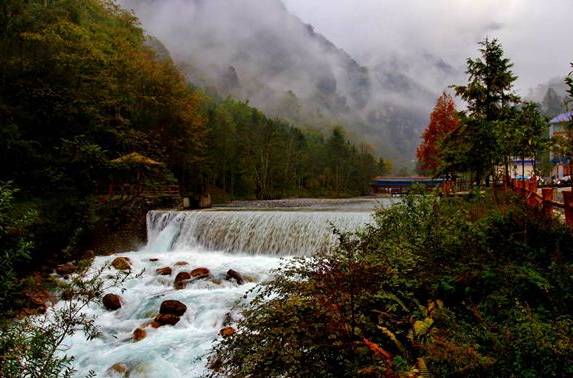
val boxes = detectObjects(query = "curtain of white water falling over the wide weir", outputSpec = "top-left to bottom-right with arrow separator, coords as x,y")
146,210 -> 371,256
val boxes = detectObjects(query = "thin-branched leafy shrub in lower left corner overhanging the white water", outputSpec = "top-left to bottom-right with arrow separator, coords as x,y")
0,266 -> 129,378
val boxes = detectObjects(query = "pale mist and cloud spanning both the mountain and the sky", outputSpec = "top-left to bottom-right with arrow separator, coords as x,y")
121,0 -> 573,161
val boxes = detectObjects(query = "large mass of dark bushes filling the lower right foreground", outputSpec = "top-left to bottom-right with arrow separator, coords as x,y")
213,194 -> 573,377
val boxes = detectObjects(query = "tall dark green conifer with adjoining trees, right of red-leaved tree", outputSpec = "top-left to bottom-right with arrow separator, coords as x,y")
441,39 -> 549,184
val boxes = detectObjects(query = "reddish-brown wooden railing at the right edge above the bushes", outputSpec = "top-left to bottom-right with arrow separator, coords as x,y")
512,177 -> 573,229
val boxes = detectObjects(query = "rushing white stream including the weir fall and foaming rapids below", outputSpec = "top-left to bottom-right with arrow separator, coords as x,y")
66,200 -> 392,378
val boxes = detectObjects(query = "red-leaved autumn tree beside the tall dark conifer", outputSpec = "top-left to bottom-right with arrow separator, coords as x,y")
416,92 -> 460,173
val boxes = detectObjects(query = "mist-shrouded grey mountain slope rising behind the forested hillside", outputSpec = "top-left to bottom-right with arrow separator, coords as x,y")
123,0 -> 442,160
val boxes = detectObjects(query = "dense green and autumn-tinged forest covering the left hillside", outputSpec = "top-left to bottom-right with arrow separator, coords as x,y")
0,0 -> 384,296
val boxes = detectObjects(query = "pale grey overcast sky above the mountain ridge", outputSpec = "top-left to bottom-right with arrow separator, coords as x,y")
283,0 -> 573,94
